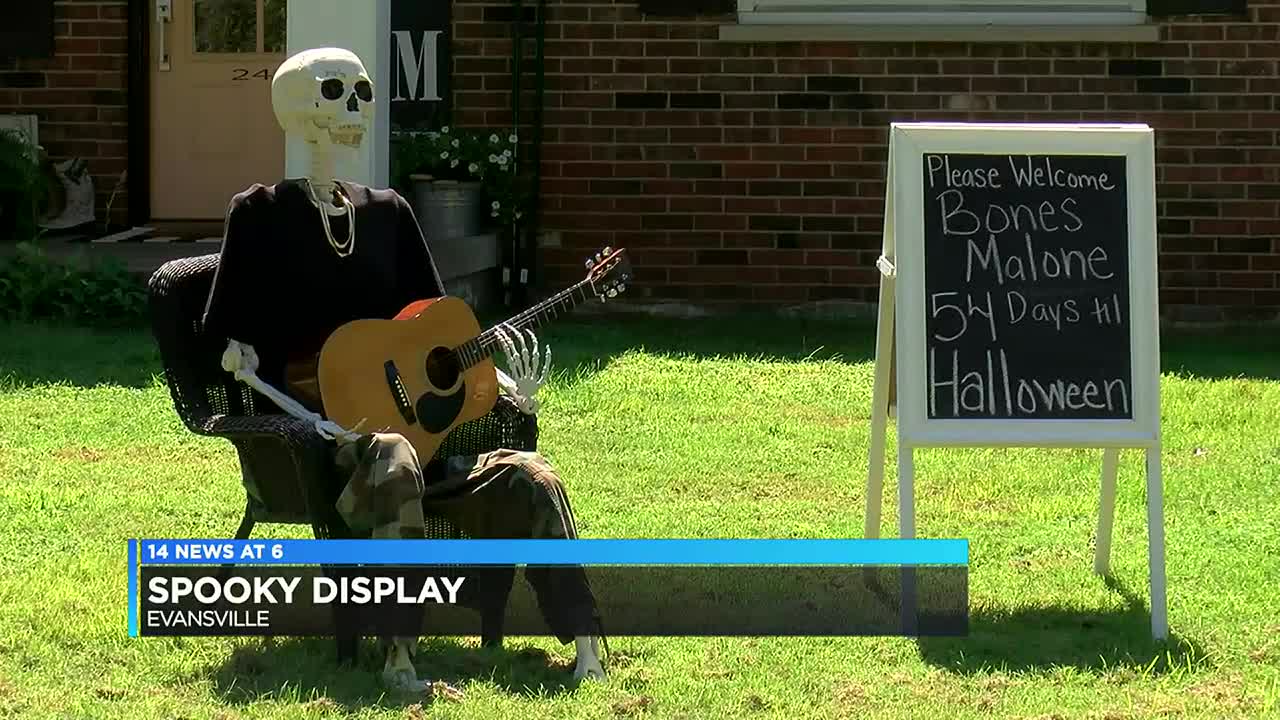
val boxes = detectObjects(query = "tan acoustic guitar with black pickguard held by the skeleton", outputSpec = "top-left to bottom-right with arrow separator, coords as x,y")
287,247 -> 631,461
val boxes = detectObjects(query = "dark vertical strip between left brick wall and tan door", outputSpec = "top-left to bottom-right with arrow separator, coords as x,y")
125,0 -> 155,225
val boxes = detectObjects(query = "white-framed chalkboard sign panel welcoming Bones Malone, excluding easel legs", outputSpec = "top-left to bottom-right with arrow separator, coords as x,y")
877,123 -> 1160,447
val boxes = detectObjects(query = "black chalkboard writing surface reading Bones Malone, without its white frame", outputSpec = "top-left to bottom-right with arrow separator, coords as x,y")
922,152 -> 1133,419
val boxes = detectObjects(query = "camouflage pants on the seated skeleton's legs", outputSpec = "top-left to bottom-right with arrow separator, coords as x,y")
327,433 -> 596,642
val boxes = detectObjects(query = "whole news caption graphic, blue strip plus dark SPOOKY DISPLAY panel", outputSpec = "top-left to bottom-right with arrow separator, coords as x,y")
128,539 -> 969,637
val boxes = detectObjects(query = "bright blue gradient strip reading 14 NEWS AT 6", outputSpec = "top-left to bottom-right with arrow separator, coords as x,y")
129,539 -> 969,568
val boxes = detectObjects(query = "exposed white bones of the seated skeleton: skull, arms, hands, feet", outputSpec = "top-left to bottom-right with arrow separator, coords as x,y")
221,47 -> 604,689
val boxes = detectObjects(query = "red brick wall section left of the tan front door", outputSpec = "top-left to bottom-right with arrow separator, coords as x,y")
0,0 -> 128,222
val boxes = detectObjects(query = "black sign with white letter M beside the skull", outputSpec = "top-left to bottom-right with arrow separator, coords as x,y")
390,0 -> 453,131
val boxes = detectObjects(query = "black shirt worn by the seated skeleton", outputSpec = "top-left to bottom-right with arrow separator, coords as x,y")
205,179 -> 444,400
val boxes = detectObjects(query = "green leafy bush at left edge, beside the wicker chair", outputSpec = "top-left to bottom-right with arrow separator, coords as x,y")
0,243 -> 147,327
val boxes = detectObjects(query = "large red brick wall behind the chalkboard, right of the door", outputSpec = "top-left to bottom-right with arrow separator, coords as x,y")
454,0 -> 1280,316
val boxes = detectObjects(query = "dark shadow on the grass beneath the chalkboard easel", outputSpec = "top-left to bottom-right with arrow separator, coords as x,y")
916,577 -> 1208,675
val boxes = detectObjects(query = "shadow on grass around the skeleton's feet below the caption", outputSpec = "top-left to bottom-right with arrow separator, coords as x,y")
207,638 -> 573,712
